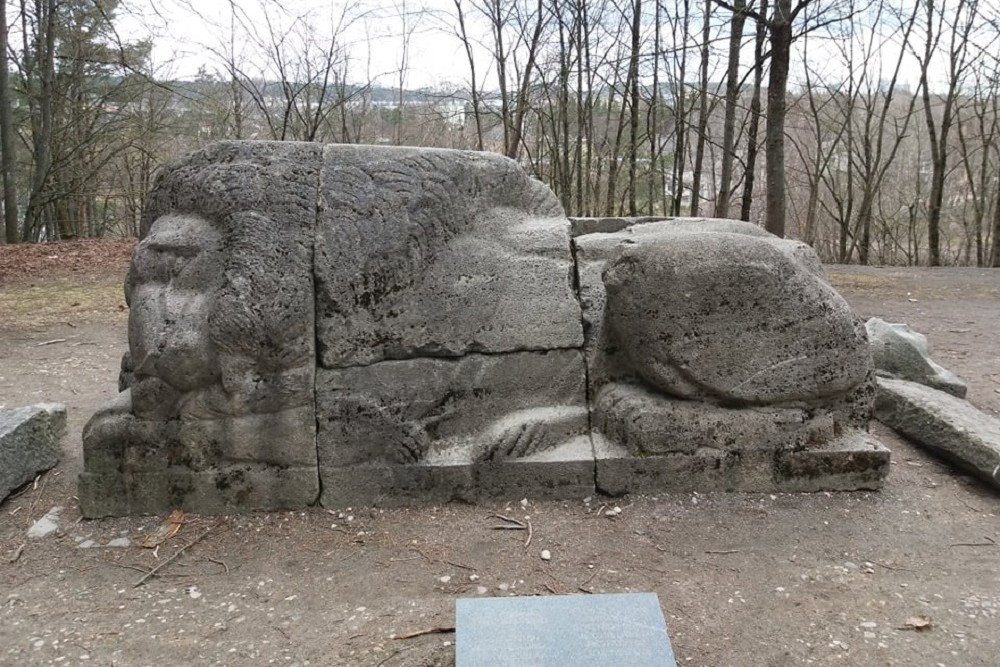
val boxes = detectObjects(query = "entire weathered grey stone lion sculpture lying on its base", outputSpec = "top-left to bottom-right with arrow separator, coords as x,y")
80,142 -> 888,516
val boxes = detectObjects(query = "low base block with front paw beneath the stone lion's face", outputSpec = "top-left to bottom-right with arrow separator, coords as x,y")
77,390 -> 319,518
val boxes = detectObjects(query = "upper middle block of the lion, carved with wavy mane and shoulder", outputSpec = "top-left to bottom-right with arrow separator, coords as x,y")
316,146 -> 583,368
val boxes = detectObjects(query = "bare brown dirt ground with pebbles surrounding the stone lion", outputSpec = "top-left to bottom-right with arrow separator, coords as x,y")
0,258 -> 1000,667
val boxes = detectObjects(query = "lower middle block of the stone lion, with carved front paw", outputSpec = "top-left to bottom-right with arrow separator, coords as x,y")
316,350 -> 593,505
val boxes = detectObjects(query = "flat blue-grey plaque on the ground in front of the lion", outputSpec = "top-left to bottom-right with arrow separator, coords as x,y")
455,593 -> 677,667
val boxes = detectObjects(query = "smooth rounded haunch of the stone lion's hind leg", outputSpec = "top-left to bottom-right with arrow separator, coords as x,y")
603,233 -> 871,405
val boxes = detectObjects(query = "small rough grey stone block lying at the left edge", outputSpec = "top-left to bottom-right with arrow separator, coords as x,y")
0,403 -> 66,502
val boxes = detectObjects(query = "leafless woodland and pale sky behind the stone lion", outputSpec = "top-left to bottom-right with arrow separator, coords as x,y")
0,0 -> 1000,266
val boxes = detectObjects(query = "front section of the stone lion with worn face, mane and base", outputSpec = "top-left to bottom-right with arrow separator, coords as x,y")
79,142 -> 322,516
